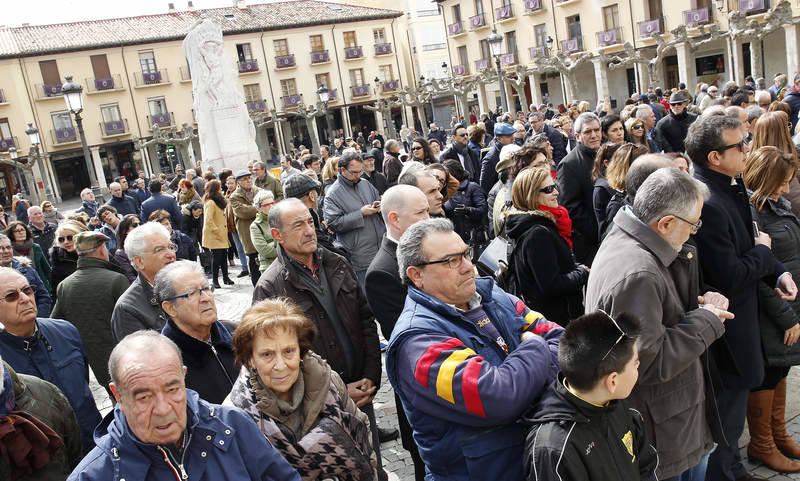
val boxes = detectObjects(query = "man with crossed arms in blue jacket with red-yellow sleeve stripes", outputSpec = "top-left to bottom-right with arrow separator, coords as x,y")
386,219 -> 563,481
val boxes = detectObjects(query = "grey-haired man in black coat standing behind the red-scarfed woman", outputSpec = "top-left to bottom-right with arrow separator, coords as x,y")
556,112 -> 602,267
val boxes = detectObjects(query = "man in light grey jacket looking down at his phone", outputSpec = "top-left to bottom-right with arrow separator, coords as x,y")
323,149 -> 386,289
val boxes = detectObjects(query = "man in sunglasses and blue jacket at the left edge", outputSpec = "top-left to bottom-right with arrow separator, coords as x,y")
0,267 -> 101,454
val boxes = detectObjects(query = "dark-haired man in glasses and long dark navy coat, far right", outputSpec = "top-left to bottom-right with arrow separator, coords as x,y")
692,115 -> 797,480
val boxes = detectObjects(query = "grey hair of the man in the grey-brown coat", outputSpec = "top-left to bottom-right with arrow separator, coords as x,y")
633,167 -> 709,225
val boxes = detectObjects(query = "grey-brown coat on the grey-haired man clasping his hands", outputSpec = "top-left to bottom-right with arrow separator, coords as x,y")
586,208 -> 736,478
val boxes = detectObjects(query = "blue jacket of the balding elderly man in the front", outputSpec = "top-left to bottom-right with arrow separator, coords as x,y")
67,389 -> 300,481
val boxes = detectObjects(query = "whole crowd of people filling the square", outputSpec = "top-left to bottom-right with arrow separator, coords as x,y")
0,74 -> 800,481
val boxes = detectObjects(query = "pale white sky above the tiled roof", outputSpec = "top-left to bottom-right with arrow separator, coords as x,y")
0,0 -> 253,27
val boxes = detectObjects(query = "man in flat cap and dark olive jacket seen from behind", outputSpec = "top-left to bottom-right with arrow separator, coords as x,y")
51,231 -> 130,386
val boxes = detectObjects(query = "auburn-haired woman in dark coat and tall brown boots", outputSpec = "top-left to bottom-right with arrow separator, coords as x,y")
742,144 -> 800,472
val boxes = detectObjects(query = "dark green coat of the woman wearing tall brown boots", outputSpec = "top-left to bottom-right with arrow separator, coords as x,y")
753,193 -> 800,366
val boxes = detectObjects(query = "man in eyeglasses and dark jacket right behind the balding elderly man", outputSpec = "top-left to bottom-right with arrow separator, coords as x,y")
153,261 -> 236,404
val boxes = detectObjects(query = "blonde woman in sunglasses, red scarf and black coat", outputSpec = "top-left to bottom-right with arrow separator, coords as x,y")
505,168 -> 589,326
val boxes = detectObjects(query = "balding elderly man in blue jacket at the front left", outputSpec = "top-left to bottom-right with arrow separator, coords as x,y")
67,331 -> 300,481
